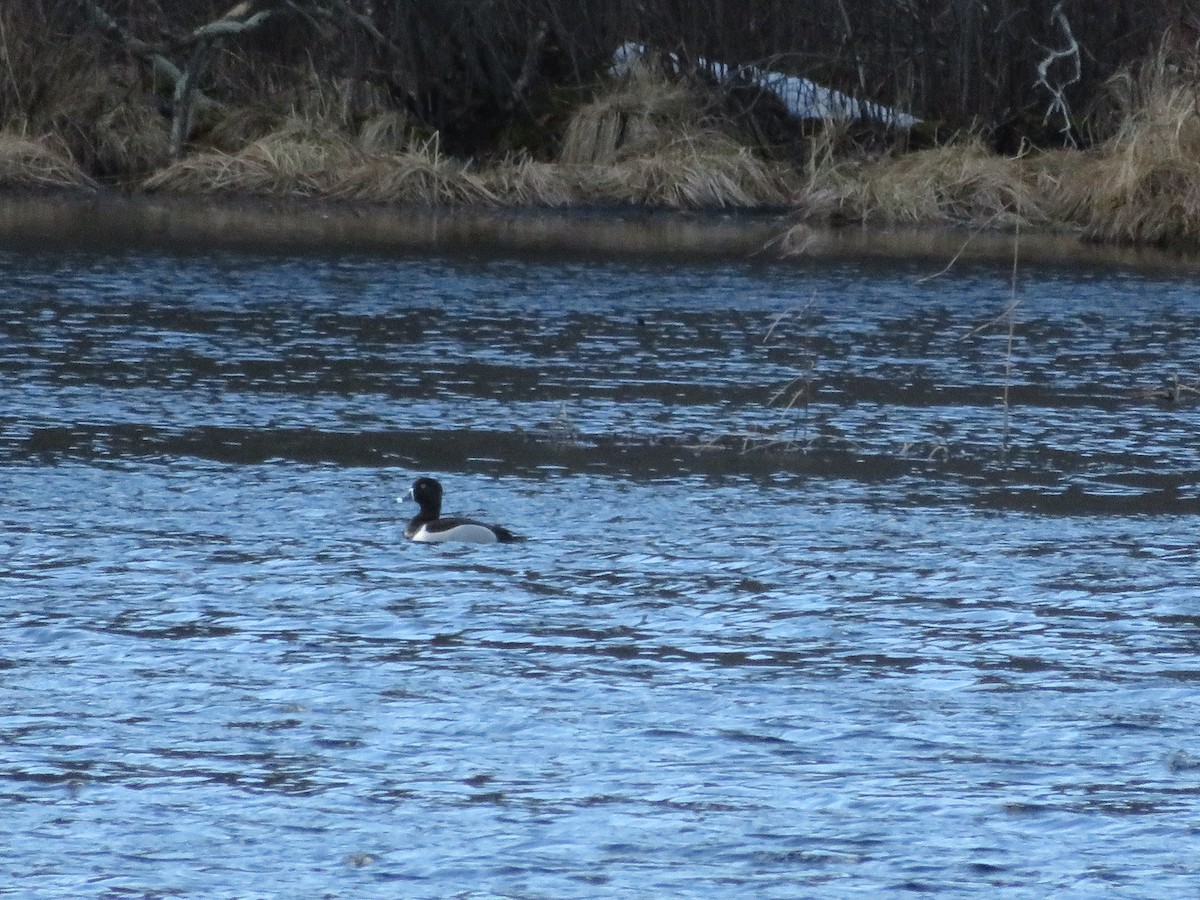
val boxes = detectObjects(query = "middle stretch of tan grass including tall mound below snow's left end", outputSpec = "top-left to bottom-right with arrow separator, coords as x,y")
145,68 -> 798,209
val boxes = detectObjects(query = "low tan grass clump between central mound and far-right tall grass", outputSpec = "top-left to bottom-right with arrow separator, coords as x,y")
802,139 -> 1048,227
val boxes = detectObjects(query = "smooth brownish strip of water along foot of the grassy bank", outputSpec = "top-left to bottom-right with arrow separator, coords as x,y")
0,188 -> 1200,274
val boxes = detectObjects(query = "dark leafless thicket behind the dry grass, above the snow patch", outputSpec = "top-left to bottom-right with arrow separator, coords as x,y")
0,0 -> 1193,162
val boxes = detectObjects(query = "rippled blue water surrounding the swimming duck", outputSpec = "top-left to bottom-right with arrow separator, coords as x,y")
0,248 -> 1200,898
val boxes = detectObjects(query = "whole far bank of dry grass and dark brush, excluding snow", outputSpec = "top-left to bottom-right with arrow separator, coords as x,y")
7,0 -> 1200,247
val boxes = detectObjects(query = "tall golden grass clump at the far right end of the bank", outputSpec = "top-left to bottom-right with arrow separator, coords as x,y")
1056,54 -> 1200,244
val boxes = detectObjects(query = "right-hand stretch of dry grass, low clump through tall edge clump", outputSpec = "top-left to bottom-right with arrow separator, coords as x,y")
772,41 -> 1200,246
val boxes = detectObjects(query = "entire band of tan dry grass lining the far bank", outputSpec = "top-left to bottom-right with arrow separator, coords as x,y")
9,15 -> 1200,246
